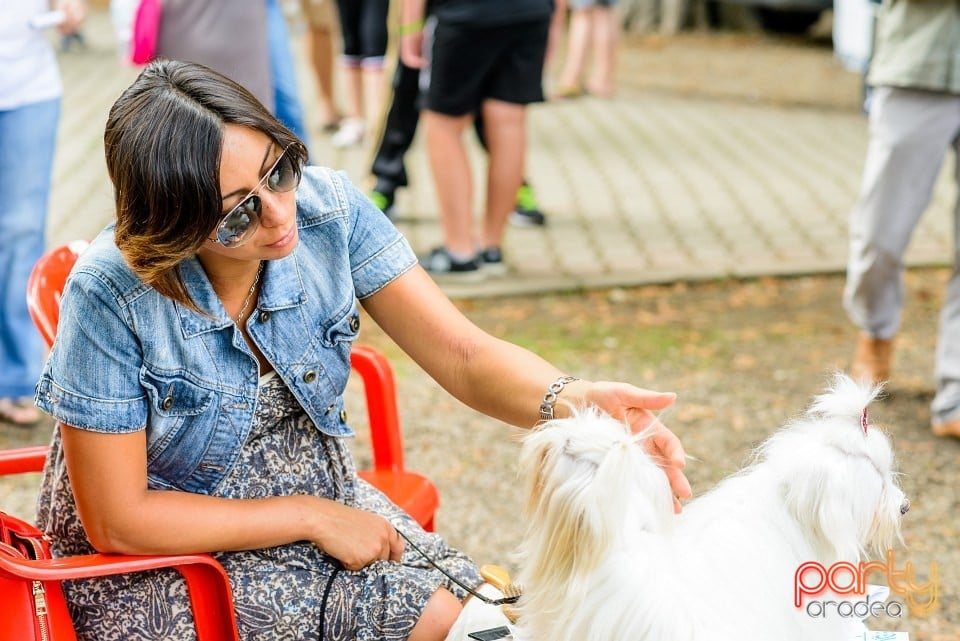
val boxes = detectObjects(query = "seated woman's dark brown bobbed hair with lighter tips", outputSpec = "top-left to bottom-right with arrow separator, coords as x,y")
103,60 -> 307,309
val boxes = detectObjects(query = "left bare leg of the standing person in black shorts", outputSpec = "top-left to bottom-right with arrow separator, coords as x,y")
420,111 -> 476,258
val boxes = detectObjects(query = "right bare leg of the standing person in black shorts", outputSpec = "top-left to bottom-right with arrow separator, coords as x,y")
481,100 -> 527,249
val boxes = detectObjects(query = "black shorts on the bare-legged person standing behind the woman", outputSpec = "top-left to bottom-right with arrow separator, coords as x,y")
425,20 -> 550,116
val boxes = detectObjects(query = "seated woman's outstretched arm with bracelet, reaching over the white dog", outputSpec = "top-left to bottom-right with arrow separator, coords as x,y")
363,266 -> 690,498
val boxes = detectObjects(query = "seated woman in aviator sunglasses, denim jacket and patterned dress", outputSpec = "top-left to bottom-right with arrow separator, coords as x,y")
30,61 -> 689,641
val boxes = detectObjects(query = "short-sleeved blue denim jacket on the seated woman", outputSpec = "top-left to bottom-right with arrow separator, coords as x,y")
36,167 -> 416,494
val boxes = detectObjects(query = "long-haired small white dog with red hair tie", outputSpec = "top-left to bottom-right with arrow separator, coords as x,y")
517,374 -> 909,641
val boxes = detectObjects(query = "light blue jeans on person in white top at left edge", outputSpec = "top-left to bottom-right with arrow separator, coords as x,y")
0,98 -> 60,398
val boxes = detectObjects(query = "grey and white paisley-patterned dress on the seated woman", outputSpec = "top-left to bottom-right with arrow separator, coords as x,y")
38,374 -> 481,641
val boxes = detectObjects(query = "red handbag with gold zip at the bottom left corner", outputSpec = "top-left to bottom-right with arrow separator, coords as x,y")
0,512 -> 76,641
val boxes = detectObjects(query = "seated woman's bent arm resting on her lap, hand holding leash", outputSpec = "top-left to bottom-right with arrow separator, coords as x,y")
60,424 -> 403,570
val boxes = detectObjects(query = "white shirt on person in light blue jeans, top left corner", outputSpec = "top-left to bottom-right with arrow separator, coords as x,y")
0,0 -> 63,111
